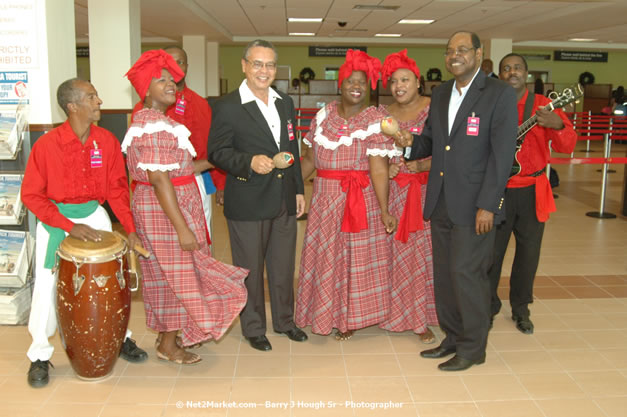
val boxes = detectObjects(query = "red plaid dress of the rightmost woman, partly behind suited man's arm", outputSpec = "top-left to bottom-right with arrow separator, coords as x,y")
379,106 -> 438,334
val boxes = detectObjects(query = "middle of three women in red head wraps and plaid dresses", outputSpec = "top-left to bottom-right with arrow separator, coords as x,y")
295,50 -> 396,340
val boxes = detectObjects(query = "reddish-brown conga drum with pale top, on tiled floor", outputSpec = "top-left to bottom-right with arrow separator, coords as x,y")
57,231 -> 131,380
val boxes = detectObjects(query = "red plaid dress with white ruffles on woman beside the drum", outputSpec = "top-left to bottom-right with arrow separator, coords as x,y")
122,109 -> 248,346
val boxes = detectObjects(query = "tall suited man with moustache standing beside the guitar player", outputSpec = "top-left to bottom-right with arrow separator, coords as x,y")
397,32 -> 518,371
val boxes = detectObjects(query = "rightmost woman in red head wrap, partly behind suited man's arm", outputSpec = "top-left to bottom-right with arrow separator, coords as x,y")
379,49 -> 438,343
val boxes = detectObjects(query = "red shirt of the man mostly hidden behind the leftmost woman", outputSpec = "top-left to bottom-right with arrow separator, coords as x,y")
133,85 -> 226,190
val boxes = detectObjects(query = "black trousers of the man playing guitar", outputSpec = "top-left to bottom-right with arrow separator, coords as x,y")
489,185 -> 544,317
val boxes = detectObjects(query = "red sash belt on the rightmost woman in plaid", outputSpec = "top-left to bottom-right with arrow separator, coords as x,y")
394,172 -> 429,243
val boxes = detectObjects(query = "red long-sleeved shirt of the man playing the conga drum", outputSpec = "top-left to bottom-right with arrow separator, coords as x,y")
21,120 -> 135,233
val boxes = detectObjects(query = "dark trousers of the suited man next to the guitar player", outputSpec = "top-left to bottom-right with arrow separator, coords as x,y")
431,193 -> 495,360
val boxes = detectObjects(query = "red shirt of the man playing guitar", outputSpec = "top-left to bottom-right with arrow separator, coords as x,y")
508,91 -> 577,186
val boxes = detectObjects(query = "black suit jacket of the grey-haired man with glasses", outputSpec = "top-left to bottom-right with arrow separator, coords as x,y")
207,90 -> 304,220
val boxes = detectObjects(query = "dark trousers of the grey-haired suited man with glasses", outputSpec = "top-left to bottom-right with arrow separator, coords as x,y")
227,203 -> 296,337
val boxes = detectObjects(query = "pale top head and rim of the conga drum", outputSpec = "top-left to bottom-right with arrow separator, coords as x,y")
58,230 -> 126,263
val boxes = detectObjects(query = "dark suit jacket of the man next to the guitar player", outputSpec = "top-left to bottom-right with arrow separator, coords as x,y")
410,71 -> 518,226
